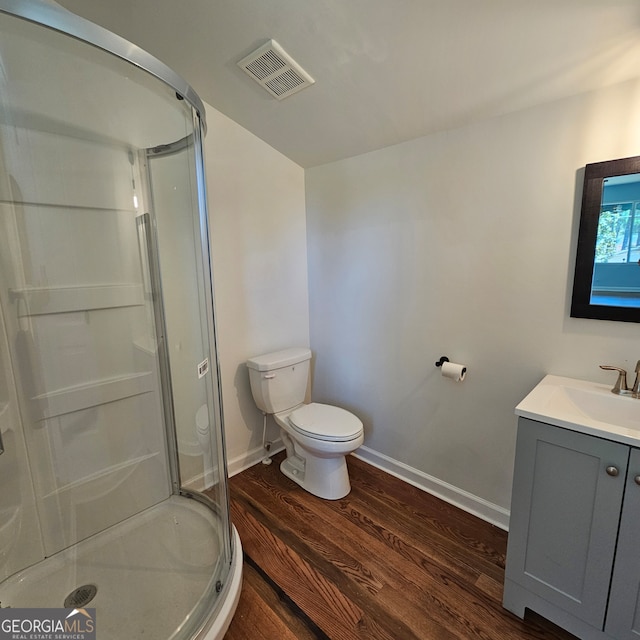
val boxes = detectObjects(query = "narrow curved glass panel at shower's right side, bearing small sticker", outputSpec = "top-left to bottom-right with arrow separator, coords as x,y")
147,127 -> 230,546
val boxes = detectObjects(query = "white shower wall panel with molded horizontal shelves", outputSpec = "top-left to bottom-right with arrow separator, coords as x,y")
0,122 -> 170,562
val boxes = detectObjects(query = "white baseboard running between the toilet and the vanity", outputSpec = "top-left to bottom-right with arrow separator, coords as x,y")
352,446 -> 510,531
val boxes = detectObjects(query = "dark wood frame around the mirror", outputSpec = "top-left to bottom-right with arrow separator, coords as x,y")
571,156 -> 640,322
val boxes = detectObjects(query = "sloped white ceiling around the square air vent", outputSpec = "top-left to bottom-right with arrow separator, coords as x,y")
58,0 -> 640,167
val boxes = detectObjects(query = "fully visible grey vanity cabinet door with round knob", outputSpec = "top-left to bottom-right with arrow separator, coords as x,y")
506,418 -> 629,629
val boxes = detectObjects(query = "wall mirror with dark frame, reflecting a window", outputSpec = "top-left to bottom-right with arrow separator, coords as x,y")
571,156 -> 640,322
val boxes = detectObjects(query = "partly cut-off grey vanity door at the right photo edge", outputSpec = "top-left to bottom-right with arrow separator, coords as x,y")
605,449 -> 640,640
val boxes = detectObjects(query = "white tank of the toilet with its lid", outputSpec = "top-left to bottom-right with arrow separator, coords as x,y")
247,348 -> 311,413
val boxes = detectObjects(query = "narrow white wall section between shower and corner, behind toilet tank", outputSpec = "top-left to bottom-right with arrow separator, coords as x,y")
205,105 -> 309,474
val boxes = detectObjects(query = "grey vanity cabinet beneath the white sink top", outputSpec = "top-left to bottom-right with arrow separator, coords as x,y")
503,418 -> 640,640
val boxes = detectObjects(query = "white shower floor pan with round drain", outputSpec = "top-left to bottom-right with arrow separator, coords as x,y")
0,496 -> 241,640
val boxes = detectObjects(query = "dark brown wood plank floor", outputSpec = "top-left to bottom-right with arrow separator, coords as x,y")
225,454 -> 573,640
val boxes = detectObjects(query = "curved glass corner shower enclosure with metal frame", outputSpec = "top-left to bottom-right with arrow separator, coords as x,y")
0,0 -> 242,640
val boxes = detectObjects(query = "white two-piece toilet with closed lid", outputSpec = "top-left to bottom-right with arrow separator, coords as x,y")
247,348 -> 364,500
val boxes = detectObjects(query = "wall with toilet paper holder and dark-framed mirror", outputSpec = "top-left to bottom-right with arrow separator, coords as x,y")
306,82 -> 640,526
